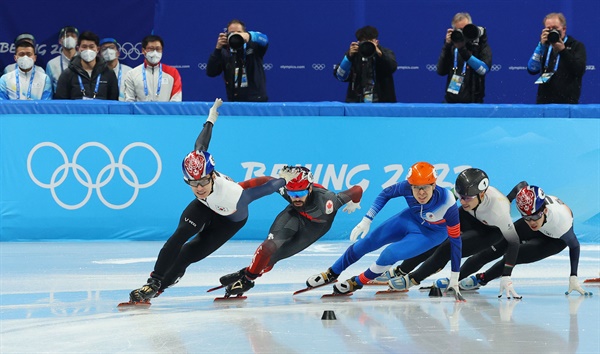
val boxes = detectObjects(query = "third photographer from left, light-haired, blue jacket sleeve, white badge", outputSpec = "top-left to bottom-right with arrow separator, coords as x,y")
437,12 -> 492,103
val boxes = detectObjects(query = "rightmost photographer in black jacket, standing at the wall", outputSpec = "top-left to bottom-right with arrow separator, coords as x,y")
527,13 -> 586,104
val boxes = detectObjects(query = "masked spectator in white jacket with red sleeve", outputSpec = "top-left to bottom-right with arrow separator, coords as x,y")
124,35 -> 182,102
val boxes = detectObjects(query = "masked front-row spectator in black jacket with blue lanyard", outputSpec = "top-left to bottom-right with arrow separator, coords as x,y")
54,31 -> 119,100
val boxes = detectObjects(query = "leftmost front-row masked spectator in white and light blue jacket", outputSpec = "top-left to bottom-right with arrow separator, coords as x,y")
0,39 -> 52,100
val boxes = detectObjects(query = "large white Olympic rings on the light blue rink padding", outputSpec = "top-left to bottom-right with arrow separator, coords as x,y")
27,142 -> 162,210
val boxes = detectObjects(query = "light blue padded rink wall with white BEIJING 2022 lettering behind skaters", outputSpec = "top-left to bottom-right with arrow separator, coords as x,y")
0,101 -> 600,244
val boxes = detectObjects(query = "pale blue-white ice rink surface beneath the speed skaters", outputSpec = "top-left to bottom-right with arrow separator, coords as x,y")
0,241 -> 600,354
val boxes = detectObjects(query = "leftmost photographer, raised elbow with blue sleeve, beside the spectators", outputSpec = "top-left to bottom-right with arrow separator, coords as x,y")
206,20 -> 269,102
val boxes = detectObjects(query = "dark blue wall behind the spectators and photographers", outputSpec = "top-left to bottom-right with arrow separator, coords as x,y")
0,0 -> 600,104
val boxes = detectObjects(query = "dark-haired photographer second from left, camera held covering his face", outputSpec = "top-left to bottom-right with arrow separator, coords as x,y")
333,26 -> 397,103
